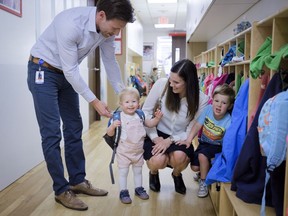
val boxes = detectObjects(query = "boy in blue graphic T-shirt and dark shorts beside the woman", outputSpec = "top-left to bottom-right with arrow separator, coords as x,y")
179,84 -> 235,197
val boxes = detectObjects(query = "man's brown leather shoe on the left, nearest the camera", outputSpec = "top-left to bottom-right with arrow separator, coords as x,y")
55,190 -> 88,211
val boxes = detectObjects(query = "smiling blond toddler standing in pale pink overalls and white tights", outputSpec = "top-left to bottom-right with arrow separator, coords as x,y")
107,87 -> 163,204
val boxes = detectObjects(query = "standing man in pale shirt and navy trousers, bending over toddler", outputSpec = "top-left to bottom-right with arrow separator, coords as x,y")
27,0 -> 134,210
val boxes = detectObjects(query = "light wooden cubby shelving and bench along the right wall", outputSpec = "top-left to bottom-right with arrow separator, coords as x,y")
194,8 -> 288,216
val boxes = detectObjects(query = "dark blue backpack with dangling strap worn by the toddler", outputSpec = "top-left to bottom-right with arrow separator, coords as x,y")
103,108 -> 145,184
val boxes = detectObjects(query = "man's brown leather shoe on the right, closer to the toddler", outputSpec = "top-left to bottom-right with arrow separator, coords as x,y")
70,180 -> 108,196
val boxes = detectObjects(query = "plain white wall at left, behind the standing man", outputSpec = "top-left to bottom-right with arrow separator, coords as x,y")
0,0 -> 89,190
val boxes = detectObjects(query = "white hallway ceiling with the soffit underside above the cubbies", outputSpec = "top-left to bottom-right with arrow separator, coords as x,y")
131,0 -> 259,42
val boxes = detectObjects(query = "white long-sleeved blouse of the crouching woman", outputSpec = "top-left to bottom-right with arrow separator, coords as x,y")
142,78 -> 209,141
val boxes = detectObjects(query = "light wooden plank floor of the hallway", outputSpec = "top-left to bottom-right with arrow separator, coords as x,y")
0,120 -> 216,216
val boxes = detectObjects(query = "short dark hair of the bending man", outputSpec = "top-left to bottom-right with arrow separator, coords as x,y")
96,0 -> 135,23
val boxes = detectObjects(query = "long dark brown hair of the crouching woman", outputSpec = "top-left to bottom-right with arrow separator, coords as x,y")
165,59 -> 199,120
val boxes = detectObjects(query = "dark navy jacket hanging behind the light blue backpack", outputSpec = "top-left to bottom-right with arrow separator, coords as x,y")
231,73 -> 285,215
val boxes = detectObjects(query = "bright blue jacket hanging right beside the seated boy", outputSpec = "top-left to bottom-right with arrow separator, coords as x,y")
206,79 -> 249,185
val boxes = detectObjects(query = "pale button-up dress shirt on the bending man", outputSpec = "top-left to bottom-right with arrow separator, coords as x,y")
31,7 -> 123,102
